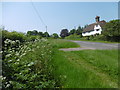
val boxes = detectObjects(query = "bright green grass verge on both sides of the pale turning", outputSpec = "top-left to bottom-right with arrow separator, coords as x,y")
51,40 -> 118,88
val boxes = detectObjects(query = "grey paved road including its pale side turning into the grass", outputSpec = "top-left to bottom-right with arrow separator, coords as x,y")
59,40 -> 120,51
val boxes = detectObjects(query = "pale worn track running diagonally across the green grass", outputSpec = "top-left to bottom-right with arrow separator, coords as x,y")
63,52 -> 117,88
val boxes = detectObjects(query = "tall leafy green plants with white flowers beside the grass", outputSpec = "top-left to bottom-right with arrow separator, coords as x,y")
1,39 -> 55,89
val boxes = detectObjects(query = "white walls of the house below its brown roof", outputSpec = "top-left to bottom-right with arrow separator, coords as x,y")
82,25 -> 102,36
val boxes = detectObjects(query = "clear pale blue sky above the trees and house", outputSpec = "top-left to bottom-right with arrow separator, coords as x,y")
0,2 -> 118,34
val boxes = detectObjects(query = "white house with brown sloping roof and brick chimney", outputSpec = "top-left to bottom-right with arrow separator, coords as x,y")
82,16 -> 106,36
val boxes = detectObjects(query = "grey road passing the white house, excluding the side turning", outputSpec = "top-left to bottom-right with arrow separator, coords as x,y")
70,40 -> 120,50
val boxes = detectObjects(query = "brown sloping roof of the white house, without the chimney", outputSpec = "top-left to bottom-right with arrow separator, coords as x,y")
83,20 -> 106,32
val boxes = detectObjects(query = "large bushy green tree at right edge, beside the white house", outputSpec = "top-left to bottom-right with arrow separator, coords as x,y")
102,20 -> 120,41
